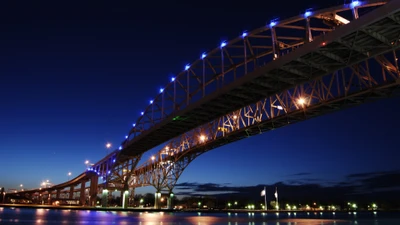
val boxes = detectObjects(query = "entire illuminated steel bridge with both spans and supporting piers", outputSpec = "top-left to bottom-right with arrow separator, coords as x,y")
5,0 -> 400,209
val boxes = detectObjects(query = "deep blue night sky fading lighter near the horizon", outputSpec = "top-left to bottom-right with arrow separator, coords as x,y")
0,0 -> 400,197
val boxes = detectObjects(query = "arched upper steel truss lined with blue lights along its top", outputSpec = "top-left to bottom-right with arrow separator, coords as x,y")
116,1 -> 398,159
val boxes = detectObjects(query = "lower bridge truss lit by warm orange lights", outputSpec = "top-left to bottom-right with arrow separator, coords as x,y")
134,48 -> 400,191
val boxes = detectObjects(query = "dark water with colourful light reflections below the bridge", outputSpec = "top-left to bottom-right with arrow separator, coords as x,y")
0,207 -> 400,225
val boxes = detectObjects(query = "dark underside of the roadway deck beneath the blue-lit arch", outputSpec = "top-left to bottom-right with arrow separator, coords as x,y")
121,1 -> 400,158
